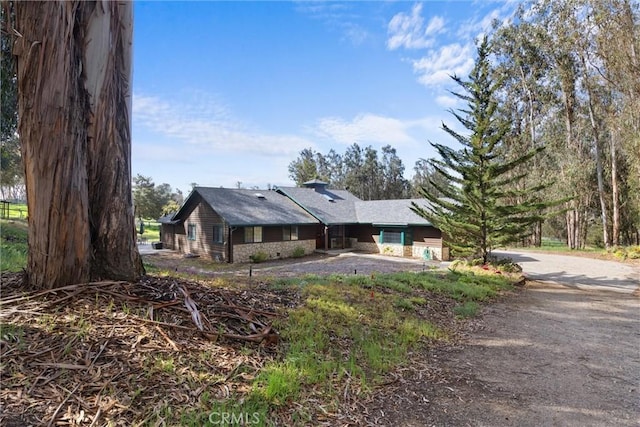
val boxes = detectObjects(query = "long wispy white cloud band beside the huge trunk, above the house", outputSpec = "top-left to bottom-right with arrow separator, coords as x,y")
133,94 -> 313,156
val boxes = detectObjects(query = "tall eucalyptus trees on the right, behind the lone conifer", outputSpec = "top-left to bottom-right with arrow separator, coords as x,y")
492,0 -> 640,248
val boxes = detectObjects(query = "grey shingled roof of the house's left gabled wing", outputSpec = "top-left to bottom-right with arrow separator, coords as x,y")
173,187 -> 318,227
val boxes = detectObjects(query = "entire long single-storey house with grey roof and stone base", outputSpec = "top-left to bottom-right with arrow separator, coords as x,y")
159,180 -> 449,262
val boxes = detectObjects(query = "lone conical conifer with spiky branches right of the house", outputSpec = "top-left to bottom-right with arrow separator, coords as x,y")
412,37 -> 553,263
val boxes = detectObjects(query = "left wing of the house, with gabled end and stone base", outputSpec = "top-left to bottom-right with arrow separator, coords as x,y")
159,187 -> 318,262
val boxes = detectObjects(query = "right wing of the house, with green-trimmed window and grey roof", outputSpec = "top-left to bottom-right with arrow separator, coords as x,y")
276,180 -> 449,260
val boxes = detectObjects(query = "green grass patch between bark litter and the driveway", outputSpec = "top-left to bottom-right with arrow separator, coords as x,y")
242,272 -> 511,419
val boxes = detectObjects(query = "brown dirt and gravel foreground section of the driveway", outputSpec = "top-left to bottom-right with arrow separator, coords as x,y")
366,282 -> 640,426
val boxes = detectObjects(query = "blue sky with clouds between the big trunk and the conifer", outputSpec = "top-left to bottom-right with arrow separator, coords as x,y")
132,0 -> 516,194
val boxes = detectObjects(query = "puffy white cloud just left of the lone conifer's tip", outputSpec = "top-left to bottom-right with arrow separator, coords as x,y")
413,43 -> 475,86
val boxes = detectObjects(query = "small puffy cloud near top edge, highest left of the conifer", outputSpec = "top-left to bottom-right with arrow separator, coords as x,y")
387,3 -> 444,50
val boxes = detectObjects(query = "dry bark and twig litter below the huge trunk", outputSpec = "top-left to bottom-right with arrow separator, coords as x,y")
0,275 -> 295,426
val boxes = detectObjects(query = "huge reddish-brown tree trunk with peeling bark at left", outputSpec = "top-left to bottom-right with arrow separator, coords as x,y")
14,1 -> 143,288
